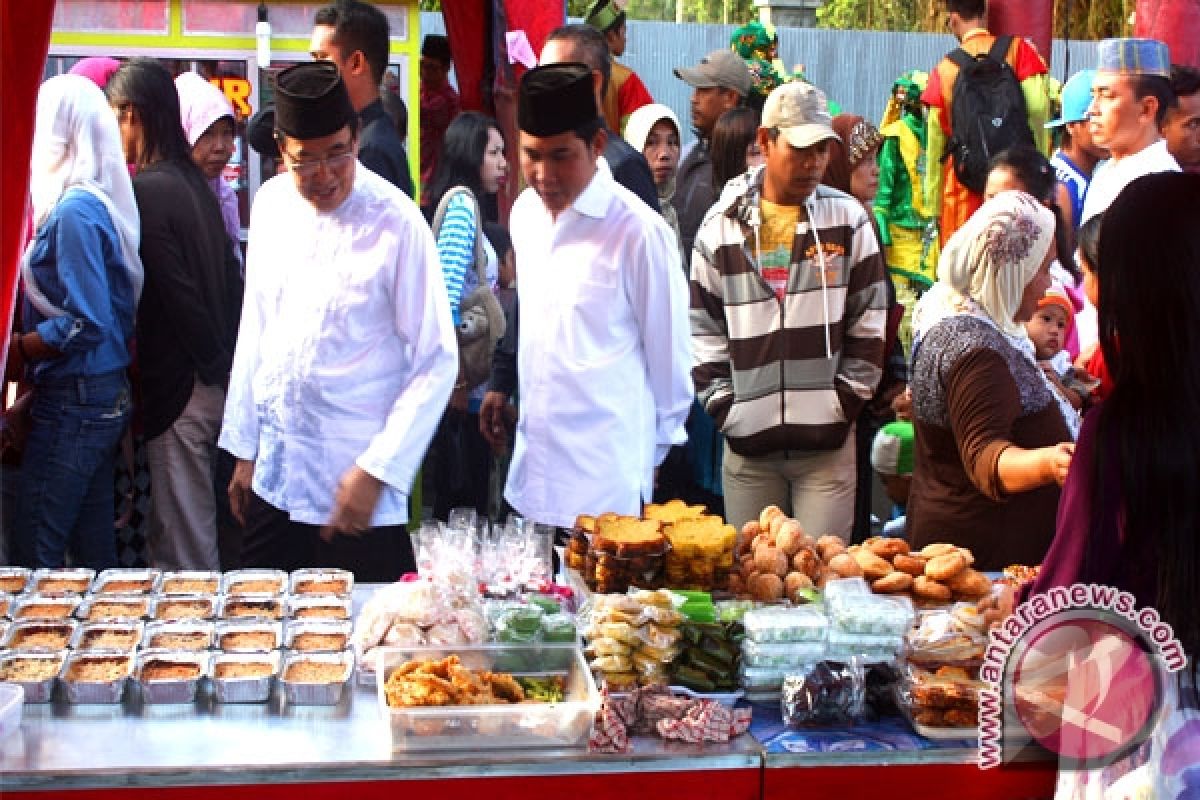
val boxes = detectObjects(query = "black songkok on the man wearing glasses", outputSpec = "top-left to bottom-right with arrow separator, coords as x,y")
275,61 -> 355,139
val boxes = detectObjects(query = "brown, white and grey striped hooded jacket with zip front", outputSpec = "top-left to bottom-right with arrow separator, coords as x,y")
690,169 -> 887,456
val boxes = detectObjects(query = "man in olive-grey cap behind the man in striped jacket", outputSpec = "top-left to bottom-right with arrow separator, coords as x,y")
671,49 -> 751,258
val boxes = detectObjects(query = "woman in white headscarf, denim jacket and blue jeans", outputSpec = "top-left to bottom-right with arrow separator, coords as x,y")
8,76 -> 143,569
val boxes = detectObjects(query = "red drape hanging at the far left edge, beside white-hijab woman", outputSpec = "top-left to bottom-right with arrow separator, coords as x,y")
0,2 -> 54,360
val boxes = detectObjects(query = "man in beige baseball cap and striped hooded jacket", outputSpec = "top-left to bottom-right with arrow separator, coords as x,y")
691,82 -> 887,539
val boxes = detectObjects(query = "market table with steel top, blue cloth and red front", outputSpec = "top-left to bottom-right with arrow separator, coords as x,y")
0,587 -> 1055,800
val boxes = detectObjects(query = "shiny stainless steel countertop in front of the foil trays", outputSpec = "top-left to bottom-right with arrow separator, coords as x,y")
0,687 -> 762,790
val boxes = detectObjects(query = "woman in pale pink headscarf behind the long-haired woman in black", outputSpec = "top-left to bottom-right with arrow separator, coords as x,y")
175,72 -> 241,268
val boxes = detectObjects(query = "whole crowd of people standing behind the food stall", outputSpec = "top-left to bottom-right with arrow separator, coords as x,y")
5,0 -> 1200,645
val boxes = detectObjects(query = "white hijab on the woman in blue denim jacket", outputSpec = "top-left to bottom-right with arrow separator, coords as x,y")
22,74 -> 144,317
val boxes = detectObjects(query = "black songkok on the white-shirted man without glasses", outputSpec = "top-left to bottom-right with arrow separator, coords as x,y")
517,64 -> 600,137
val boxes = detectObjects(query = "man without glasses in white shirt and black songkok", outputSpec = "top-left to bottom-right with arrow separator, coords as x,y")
480,64 -> 692,528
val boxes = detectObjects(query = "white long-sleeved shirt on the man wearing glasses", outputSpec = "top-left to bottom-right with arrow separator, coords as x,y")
220,164 -> 458,527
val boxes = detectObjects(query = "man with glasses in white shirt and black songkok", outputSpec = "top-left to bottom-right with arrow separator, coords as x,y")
220,62 -> 458,582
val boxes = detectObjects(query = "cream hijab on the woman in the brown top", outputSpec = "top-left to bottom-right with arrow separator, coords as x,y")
912,191 -> 1080,439
